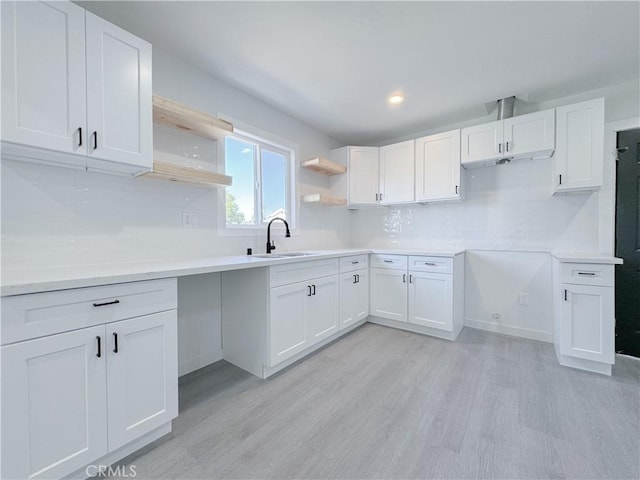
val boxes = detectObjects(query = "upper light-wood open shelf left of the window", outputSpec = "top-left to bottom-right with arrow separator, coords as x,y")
153,95 -> 233,141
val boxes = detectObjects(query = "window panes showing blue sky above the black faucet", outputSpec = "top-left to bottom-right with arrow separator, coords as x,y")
224,134 -> 293,227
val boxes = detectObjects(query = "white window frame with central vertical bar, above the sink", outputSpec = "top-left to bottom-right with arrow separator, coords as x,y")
218,124 -> 297,236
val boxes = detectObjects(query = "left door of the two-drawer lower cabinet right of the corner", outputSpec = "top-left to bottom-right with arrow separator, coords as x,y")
369,268 -> 407,322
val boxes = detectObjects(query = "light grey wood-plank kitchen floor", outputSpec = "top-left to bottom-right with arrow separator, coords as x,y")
115,324 -> 640,479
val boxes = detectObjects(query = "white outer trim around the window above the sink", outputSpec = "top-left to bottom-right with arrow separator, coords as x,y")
216,113 -> 300,237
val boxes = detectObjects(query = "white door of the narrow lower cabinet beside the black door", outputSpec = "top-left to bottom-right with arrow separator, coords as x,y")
560,283 -> 615,364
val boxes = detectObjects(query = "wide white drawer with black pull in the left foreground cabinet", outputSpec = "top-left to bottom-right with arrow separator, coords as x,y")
2,278 -> 178,345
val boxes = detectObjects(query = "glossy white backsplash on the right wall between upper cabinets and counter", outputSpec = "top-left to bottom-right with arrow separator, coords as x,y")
352,159 -> 598,251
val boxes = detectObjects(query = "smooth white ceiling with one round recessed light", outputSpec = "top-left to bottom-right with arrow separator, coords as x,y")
78,1 -> 640,144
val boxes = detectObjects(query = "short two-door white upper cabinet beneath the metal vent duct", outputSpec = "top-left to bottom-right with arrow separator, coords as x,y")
461,109 -> 555,167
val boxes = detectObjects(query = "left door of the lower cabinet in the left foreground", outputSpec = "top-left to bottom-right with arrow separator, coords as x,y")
1,326 -> 107,478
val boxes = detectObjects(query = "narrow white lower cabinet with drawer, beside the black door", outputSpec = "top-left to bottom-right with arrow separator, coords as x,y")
553,259 -> 615,375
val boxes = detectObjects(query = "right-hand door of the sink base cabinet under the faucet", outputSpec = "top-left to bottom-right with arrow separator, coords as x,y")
305,275 -> 340,346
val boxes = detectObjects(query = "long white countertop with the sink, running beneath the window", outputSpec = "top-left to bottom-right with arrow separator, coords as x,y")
1,249 -> 464,297
